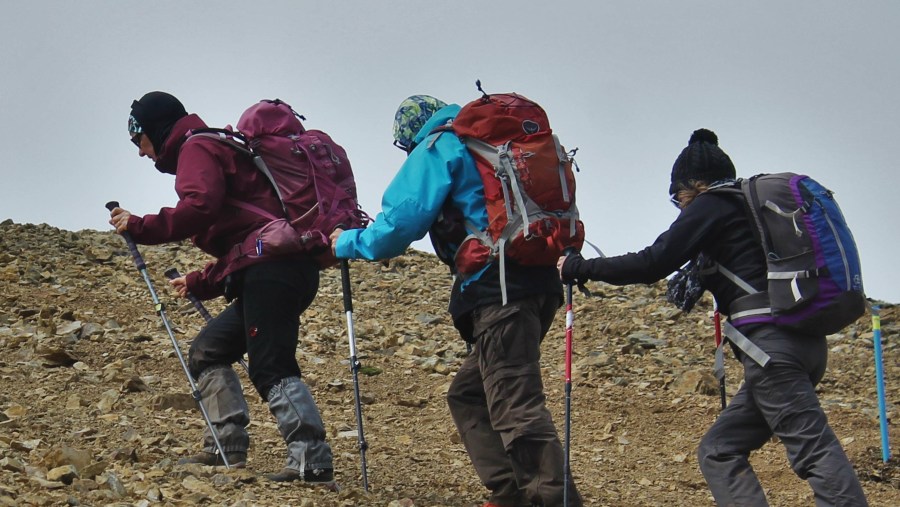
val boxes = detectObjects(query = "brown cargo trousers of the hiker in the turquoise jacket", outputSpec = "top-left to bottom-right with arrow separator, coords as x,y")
447,295 -> 582,507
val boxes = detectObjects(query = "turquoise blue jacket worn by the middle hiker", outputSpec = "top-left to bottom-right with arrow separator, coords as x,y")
335,104 -> 487,266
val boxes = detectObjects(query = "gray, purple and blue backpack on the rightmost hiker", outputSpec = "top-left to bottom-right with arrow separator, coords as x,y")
713,173 -> 866,335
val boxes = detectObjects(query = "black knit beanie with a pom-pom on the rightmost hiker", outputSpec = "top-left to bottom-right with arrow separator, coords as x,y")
669,129 -> 737,195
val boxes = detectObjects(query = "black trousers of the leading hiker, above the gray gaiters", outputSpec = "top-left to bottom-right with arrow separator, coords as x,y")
189,259 -> 319,400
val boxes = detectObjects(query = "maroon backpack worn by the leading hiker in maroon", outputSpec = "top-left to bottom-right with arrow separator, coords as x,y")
193,99 -> 369,269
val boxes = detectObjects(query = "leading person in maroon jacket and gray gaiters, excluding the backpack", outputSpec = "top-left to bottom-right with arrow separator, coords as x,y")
109,91 -> 333,484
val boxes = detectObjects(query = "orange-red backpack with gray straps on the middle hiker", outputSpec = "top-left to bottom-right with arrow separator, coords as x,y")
449,87 -> 584,304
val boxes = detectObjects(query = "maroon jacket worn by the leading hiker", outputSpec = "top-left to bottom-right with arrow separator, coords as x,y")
128,114 -> 283,299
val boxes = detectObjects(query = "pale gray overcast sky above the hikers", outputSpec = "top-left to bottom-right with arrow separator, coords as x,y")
0,0 -> 900,302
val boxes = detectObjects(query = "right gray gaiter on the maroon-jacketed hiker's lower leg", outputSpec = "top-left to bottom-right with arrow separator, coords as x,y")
267,377 -> 334,473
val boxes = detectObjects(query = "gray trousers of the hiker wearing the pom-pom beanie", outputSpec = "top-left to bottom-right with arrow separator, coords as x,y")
697,326 -> 868,507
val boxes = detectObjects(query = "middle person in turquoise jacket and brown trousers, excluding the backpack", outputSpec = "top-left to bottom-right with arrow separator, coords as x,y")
331,95 -> 581,507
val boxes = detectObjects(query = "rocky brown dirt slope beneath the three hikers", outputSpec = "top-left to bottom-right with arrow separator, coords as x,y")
0,221 -> 900,507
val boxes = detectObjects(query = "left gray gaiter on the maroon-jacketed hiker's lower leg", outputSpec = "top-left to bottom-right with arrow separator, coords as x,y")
197,365 -> 250,453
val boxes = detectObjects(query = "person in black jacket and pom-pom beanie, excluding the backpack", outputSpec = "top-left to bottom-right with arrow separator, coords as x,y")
557,129 -> 867,506
